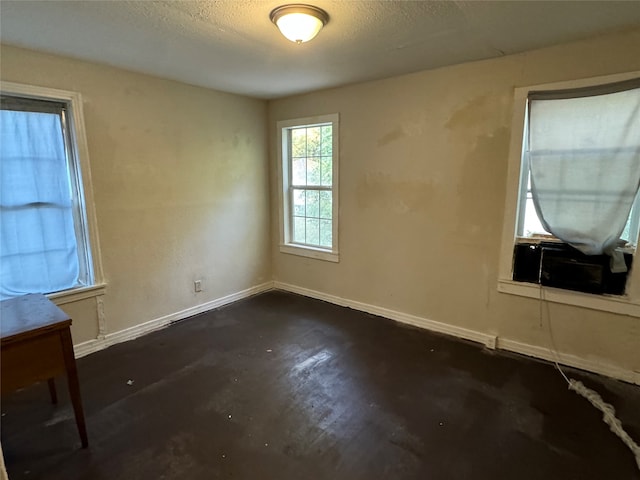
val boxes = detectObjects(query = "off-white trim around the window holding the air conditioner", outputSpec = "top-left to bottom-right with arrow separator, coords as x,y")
498,71 -> 640,317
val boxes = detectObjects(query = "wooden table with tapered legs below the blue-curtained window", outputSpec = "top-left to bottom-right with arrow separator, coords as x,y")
0,294 -> 89,448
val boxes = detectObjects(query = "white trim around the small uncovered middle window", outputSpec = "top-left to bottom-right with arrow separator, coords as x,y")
277,113 -> 340,262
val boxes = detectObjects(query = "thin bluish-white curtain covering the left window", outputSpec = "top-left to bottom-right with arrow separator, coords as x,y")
0,110 -> 79,299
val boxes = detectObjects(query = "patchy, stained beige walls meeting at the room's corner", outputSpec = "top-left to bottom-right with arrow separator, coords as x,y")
0,31 -> 640,378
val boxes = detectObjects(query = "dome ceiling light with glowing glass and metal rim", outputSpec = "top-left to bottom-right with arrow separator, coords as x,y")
269,3 -> 329,43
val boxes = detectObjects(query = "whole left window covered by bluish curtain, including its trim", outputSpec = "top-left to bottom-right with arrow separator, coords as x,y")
0,82 -> 101,299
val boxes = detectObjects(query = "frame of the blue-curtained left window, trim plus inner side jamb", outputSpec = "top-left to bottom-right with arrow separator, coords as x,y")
0,81 -> 105,303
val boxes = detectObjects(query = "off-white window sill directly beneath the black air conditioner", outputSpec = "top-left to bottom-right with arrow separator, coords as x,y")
498,279 -> 640,317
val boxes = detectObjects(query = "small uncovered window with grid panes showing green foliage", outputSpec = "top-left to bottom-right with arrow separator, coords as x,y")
278,114 -> 338,262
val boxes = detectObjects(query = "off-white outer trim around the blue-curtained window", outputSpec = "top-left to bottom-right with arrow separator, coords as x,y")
0,81 -> 106,304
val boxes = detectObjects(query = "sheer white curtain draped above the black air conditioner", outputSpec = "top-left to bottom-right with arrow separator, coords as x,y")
527,83 -> 640,271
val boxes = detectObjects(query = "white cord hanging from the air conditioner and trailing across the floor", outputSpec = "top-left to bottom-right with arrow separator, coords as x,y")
539,284 -> 640,470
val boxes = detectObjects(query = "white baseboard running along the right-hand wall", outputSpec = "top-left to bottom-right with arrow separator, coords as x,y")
273,281 -> 640,385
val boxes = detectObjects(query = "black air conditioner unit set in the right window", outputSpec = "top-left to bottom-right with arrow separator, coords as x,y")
513,242 -> 633,295
